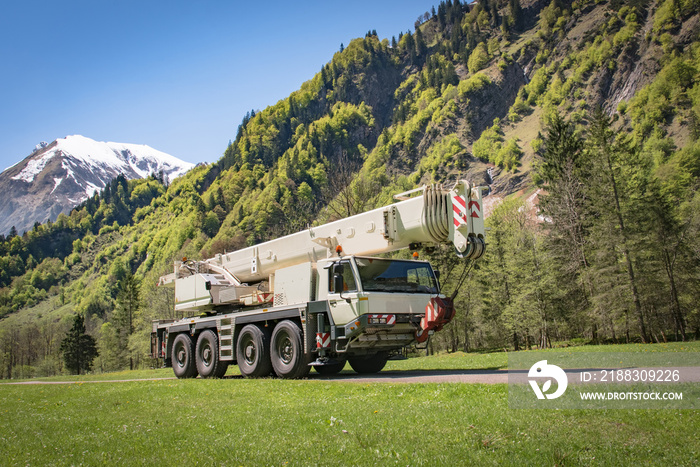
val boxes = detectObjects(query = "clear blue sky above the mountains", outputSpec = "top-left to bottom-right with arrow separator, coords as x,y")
0,0 -> 438,170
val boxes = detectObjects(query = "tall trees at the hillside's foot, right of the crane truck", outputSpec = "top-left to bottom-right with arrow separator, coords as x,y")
432,109 -> 700,350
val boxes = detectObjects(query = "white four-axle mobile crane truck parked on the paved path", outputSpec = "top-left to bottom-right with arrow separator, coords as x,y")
151,180 -> 485,378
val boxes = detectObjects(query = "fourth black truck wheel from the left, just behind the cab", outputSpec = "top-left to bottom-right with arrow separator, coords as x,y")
270,320 -> 311,379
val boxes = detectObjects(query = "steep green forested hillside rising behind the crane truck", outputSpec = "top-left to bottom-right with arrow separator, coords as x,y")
0,0 -> 700,378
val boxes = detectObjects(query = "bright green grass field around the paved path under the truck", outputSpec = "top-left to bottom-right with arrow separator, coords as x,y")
0,343 -> 700,465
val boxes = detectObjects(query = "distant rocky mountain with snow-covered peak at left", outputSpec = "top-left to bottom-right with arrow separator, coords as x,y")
0,135 -> 194,234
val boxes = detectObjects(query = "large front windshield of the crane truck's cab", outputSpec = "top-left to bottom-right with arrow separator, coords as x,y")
355,258 -> 439,294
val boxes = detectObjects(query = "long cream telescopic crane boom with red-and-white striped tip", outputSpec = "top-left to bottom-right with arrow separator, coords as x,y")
174,180 -> 484,285
